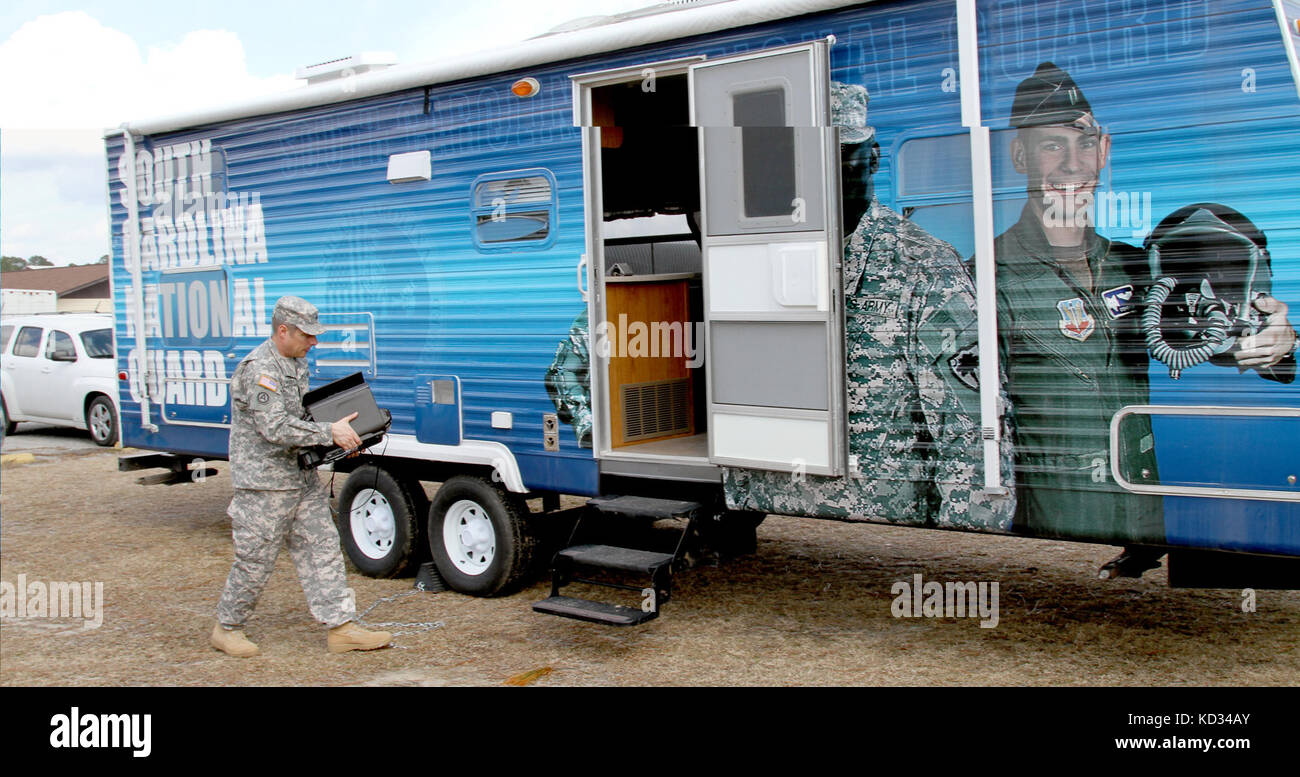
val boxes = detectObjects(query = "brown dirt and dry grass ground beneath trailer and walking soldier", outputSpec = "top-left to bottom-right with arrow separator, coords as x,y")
0,451 -> 1300,686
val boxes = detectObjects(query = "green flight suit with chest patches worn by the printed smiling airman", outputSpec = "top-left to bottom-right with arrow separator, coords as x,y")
995,207 -> 1165,543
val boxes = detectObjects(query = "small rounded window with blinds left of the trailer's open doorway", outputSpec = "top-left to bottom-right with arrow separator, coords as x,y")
471,170 -> 555,249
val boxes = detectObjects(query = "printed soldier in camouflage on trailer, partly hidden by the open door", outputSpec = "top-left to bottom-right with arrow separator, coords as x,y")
723,83 -> 1015,531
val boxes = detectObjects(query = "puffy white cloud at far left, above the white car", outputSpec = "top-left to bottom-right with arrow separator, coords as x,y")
0,10 -> 296,264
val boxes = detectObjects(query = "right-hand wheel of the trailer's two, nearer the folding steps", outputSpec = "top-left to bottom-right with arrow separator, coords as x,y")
429,476 -> 537,596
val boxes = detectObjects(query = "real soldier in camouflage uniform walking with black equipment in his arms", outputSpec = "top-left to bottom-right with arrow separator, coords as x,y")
211,296 -> 391,657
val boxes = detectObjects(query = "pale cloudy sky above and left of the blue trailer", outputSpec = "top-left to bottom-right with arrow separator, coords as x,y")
0,0 -> 655,265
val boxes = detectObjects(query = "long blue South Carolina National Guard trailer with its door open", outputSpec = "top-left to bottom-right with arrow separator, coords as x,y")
105,0 -> 1300,624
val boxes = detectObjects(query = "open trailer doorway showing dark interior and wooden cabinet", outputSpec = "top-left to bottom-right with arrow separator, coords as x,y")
588,68 -> 709,464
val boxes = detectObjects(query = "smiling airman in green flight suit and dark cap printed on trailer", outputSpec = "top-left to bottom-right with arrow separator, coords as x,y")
995,62 -> 1295,548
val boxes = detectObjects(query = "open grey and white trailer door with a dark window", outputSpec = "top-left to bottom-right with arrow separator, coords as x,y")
690,40 -> 845,474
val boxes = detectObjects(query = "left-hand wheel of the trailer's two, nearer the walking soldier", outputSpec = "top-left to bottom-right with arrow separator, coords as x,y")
338,464 -> 425,578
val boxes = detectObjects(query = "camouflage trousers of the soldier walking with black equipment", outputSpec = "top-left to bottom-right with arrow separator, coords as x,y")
217,483 -> 356,629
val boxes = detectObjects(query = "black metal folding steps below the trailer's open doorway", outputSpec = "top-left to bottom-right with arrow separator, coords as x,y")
533,496 -> 702,626
